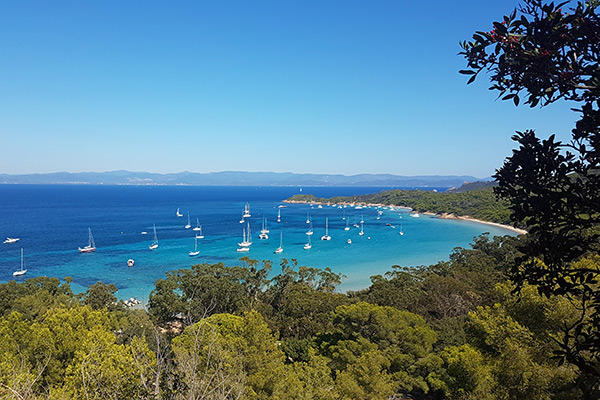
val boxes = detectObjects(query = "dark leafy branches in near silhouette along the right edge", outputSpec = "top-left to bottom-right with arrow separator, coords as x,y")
460,0 -> 600,386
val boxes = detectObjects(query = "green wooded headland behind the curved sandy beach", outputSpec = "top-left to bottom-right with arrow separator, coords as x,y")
287,187 -> 514,224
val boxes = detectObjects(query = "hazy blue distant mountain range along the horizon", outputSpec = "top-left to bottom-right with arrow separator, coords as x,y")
0,171 -> 491,187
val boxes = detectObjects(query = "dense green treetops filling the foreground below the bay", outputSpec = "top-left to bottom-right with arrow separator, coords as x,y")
0,236 -> 600,400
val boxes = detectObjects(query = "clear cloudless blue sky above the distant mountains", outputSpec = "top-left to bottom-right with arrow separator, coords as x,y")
0,0 -> 577,177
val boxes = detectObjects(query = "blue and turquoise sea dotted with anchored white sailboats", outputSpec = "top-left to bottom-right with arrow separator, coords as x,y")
0,185 -> 515,302
